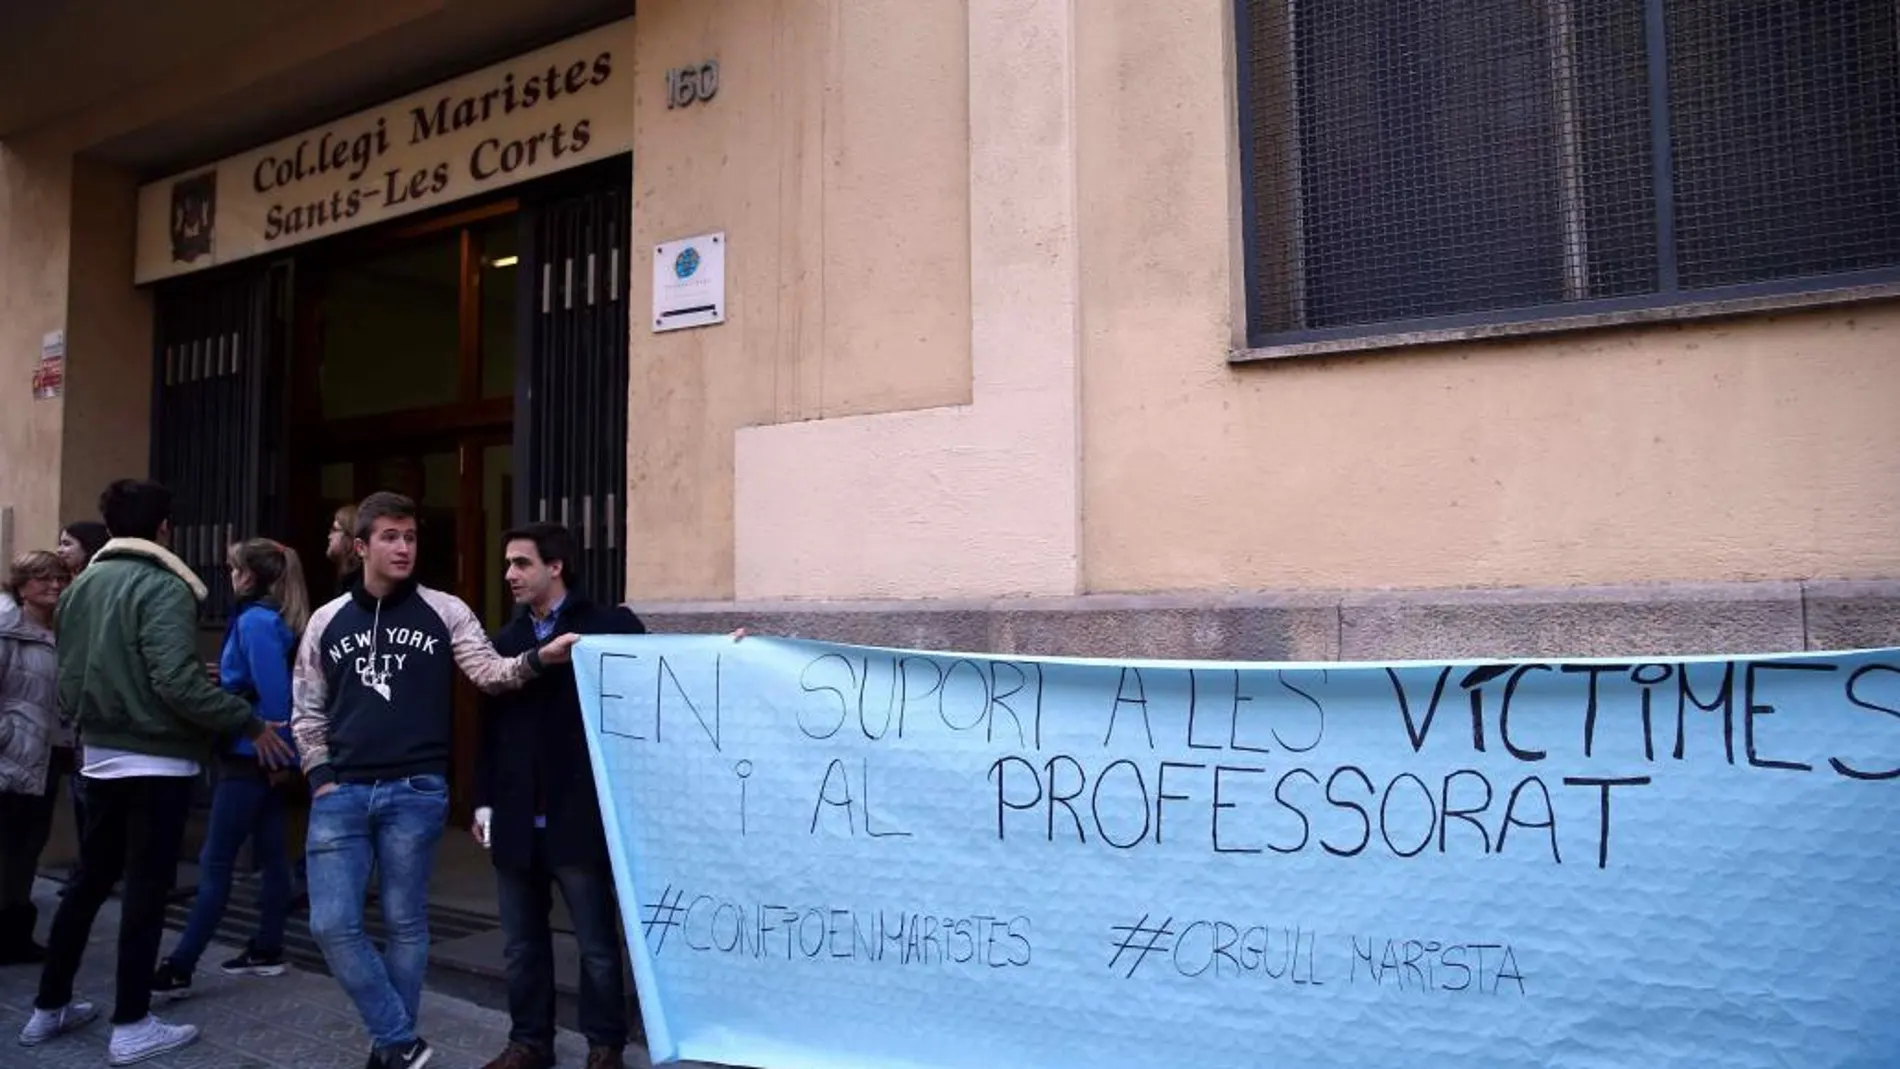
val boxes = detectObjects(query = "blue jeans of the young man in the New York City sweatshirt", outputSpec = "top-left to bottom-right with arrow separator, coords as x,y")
304,775 -> 448,1050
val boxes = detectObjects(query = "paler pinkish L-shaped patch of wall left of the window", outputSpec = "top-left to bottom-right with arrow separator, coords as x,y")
735,0 -> 1079,600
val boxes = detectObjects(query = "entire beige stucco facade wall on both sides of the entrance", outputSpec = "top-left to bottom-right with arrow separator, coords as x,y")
0,0 -> 1900,600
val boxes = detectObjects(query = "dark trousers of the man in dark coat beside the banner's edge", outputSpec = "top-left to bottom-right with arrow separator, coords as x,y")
494,832 -> 627,1050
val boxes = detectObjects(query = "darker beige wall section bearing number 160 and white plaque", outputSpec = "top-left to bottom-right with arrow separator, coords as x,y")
629,0 -> 971,598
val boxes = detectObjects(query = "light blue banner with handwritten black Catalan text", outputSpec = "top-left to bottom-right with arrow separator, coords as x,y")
576,636 -> 1900,1069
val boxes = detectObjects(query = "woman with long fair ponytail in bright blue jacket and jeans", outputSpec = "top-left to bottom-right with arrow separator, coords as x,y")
152,539 -> 310,999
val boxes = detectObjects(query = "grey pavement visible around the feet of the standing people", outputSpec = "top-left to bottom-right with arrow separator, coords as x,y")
0,879 -> 711,1069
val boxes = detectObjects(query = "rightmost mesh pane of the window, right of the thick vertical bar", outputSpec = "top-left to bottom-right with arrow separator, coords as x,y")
1668,0 -> 1900,287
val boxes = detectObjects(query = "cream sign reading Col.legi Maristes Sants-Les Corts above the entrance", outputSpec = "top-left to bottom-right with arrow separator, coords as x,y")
135,19 -> 635,285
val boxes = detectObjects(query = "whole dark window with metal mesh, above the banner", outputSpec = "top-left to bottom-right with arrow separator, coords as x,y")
1241,0 -> 1900,344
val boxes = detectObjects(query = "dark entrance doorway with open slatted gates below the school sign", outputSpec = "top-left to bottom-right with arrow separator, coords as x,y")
152,156 -> 633,891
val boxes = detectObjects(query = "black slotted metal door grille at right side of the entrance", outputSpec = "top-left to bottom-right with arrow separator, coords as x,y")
517,180 -> 633,604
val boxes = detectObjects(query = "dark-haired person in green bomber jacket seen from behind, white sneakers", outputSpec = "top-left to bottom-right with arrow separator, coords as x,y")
19,478 -> 295,1065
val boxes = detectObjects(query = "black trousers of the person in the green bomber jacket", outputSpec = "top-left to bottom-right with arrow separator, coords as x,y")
34,777 -> 194,1025
